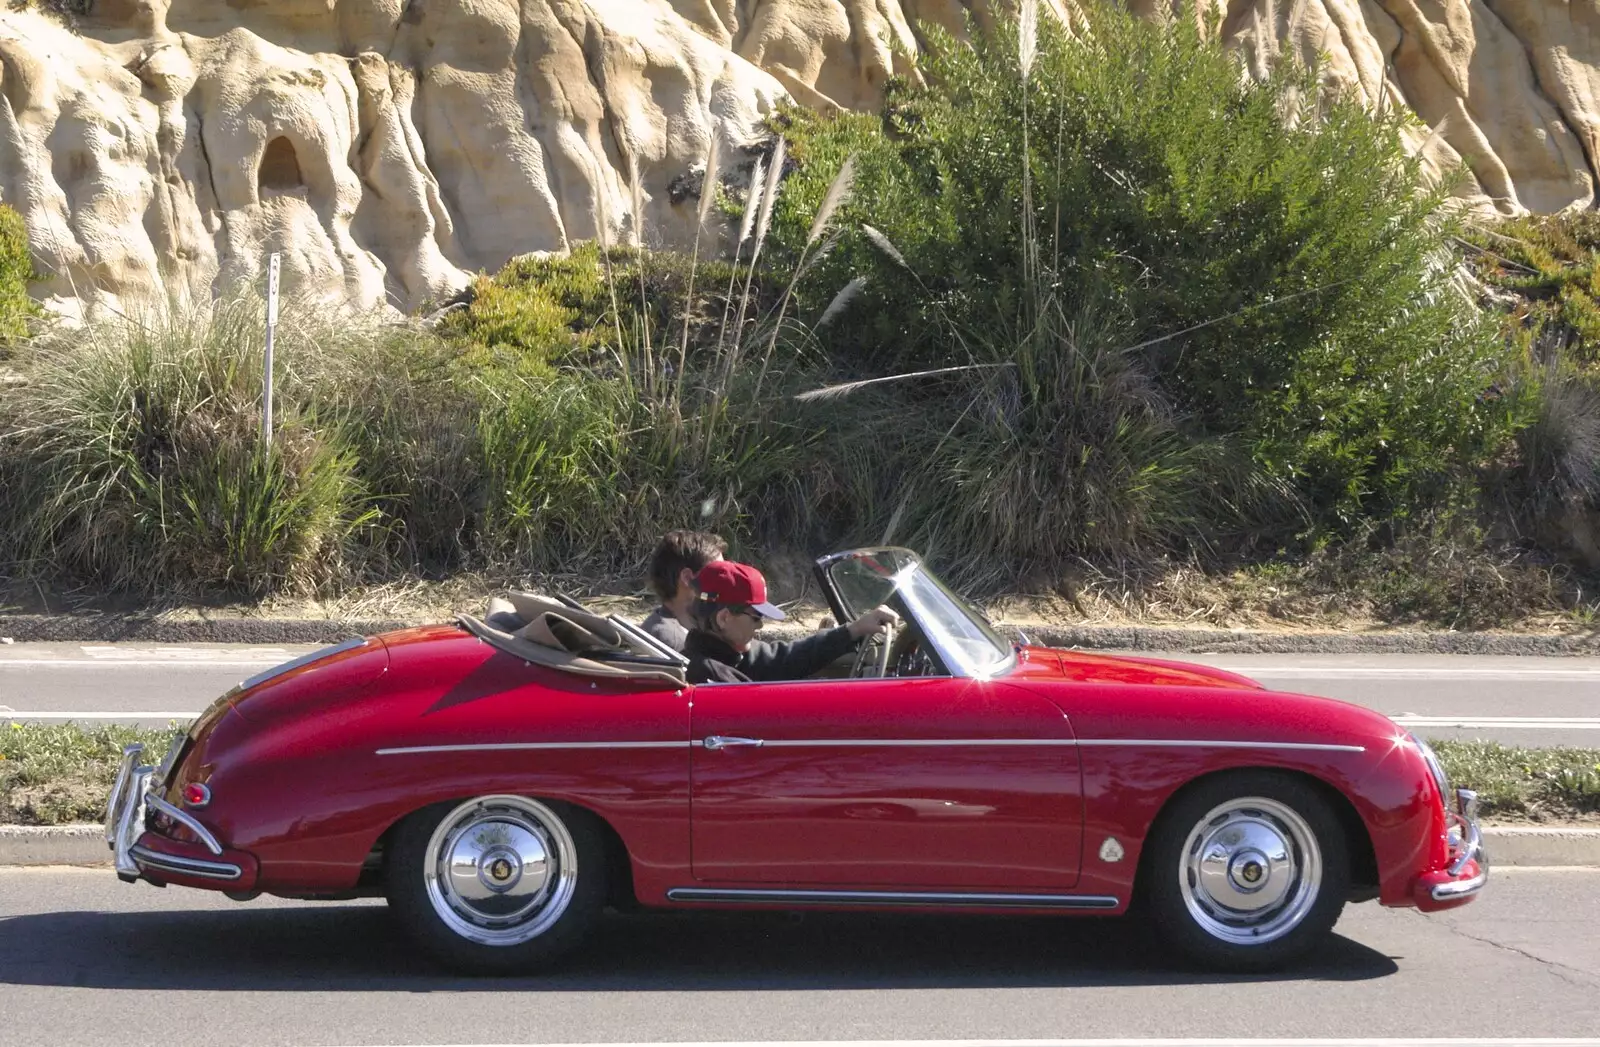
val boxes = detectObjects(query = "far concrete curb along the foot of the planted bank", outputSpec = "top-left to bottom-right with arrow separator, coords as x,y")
9,613 -> 1600,658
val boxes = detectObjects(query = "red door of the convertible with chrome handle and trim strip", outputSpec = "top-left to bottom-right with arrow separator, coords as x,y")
690,677 -> 1083,889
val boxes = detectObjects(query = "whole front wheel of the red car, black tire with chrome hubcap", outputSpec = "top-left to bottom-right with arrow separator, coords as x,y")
1141,772 -> 1350,972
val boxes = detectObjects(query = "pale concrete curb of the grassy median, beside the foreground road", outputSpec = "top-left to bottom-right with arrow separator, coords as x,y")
0,823 -> 1600,868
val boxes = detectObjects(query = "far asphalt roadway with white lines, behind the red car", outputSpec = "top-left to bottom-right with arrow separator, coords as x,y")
0,644 -> 1600,748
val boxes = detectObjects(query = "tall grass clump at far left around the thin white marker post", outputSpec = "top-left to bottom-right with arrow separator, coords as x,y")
0,299 -> 390,596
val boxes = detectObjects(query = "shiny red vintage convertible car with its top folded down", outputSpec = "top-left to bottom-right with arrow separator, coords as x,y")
106,549 -> 1488,972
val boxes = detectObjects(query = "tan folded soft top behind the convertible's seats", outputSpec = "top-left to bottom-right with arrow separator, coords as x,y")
456,592 -> 686,687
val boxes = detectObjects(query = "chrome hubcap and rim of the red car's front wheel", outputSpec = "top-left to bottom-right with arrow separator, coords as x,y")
1178,797 -> 1322,945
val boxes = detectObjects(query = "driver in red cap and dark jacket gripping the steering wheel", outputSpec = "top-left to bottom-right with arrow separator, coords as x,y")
683,560 -> 899,684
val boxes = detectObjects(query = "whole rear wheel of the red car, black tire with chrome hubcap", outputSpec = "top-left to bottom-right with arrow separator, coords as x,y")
384,794 -> 606,975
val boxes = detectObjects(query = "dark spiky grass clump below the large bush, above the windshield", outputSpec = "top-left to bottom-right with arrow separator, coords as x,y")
800,297 -> 1294,591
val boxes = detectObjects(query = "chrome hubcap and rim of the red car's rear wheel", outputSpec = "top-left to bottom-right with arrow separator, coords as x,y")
422,796 -> 578,945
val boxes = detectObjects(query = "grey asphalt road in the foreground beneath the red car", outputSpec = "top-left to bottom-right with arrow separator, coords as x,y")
0,869 -> 1600,1047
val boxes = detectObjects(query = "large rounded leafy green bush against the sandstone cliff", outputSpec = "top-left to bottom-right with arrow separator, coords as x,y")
773,5 -> 1512,557
